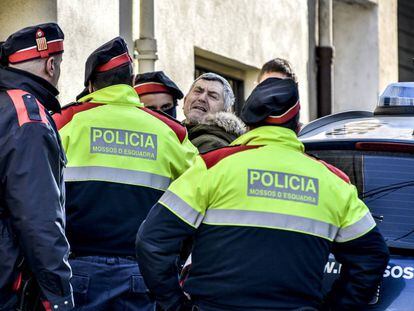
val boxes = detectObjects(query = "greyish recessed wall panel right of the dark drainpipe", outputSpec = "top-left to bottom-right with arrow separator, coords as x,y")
333,1 -> 379,112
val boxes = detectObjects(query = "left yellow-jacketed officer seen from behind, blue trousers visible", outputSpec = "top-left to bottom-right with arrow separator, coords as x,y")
54,37 -> 197,311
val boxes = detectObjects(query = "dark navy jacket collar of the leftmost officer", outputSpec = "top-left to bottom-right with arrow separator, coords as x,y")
0,66 -> 60,112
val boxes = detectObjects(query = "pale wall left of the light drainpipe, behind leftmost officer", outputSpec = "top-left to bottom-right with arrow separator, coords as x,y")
0,0 -> 119,105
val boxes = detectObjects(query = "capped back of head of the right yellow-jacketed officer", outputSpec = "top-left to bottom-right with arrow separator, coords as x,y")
240,78 -> 300,133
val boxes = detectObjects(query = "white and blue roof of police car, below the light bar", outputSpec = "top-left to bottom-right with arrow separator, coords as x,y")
299,111 -> 414,145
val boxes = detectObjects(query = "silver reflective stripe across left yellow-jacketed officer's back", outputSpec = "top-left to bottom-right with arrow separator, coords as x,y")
64,166 -> 171,191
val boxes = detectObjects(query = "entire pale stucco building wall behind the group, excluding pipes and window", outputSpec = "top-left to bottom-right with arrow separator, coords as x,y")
0,0 -> 398,122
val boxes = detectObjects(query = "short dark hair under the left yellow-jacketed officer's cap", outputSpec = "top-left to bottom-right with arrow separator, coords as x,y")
91,64 -> 133,90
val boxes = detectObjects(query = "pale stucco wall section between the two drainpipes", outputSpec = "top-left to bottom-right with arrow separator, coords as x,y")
150,0 -> 308,121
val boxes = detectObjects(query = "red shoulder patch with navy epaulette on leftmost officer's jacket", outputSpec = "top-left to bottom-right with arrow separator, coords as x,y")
7,90 -> 48,126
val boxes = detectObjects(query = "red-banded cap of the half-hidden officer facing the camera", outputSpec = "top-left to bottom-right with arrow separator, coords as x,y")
134,71 -> 184,100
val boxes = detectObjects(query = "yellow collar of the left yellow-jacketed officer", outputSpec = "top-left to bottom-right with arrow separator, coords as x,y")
79,84 -> 144,107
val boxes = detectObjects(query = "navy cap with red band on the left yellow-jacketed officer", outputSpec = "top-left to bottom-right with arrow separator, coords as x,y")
84,37 -> 132,86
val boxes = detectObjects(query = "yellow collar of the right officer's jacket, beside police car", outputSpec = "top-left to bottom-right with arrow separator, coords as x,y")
231,126 -> 305,152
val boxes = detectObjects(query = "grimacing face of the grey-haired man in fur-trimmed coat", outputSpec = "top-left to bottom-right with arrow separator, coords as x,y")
184,79 -> 224,123
